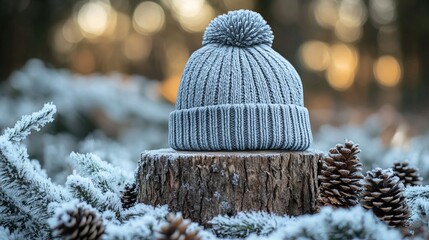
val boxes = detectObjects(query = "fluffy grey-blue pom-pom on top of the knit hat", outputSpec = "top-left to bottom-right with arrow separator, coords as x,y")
203,10 -> 274,47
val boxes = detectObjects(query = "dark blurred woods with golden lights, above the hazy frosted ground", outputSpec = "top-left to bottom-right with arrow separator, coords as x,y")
0,0 -> 429,112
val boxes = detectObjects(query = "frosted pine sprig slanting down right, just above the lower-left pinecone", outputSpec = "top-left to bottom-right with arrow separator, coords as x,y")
66,174 -> 121,217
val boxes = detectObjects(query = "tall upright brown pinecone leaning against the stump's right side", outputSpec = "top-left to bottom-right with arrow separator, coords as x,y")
319,140 -> 363,207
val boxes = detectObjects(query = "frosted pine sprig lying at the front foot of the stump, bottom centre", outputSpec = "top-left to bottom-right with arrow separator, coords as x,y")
209,212 -> 292,238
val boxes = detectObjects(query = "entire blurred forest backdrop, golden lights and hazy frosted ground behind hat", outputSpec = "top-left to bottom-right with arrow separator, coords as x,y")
0,0 -> 429,182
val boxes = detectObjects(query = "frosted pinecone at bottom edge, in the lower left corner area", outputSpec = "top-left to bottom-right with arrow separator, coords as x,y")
53,206 -> 104,240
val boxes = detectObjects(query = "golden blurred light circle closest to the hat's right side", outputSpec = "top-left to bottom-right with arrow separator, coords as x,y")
299,41 -> 330,71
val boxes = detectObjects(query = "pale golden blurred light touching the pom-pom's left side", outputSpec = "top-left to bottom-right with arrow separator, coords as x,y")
176,3 -> 215,32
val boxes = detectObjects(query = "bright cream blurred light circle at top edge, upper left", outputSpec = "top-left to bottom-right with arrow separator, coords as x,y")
77,1 -> 111,37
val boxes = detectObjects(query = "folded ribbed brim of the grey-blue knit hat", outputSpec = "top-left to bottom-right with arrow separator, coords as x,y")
168,104 -> 312,151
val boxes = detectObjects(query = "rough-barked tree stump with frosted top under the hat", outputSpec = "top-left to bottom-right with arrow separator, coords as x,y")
137,149 -> 322,225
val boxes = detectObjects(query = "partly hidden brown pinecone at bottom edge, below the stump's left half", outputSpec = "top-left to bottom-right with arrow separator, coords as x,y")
158,213 -> 201,240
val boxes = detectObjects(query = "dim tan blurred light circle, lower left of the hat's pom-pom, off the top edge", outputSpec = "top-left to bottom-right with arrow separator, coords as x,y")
122,33 -> 152,61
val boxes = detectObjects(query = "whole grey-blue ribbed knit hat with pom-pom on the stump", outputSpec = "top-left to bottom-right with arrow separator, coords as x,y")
168,10 -> 312,151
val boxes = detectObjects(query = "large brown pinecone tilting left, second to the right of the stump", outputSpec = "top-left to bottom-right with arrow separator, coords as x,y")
361,168 -> 410,227
